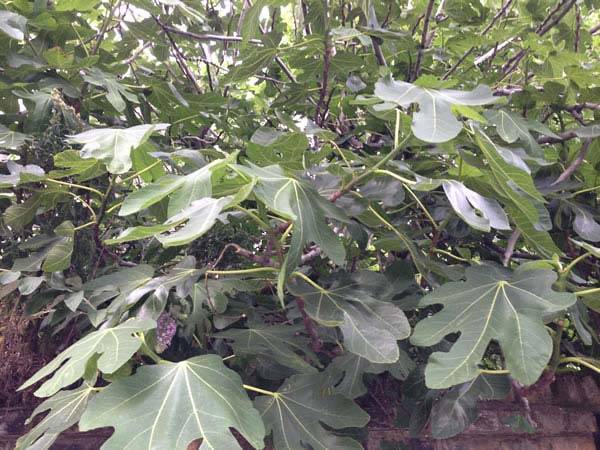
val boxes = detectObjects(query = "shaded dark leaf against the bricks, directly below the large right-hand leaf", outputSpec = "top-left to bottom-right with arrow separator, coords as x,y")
430,375 -> 511,439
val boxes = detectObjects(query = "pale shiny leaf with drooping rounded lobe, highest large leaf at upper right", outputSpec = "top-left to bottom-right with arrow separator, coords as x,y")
374,77 -> 498,143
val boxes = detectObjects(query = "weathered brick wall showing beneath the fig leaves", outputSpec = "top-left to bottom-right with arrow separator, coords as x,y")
0,376 -> 600,450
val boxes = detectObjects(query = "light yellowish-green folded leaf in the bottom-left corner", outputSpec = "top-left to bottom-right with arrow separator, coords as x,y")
15,382 -> 96,450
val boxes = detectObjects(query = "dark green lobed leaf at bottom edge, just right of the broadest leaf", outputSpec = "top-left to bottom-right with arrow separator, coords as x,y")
254,375 -> 369,450
